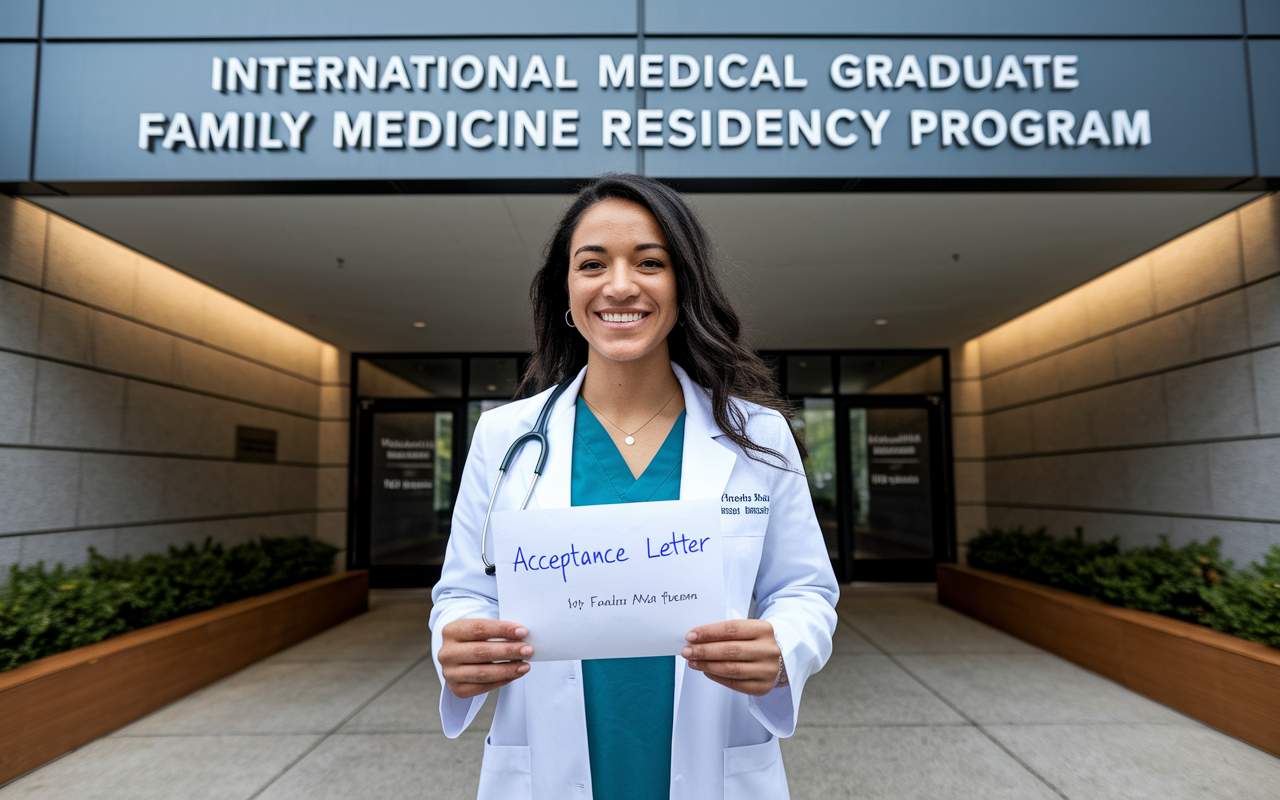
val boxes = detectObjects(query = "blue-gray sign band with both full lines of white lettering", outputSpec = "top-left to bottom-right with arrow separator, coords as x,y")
36,37 -> 1253,182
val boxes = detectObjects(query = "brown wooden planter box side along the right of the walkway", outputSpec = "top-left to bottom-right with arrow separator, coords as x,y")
938,564 -> 1280,755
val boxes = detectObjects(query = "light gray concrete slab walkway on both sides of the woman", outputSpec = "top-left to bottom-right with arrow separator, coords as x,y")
0,586 -> 1280,800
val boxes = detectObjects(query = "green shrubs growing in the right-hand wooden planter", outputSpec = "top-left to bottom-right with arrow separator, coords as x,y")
969,526 -> 1280,648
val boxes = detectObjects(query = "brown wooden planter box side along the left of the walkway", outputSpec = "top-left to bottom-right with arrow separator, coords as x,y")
0,571 -> 369,783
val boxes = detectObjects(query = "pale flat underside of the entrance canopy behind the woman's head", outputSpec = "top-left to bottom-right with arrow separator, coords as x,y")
35,192 -> 1254,352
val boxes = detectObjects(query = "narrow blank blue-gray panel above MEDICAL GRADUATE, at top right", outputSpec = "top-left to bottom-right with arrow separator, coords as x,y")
645,0 -> 1239,36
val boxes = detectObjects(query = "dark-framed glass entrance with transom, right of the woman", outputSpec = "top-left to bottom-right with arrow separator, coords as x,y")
765,351 -> 952,581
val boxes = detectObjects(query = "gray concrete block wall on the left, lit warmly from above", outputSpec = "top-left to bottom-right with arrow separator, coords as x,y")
0,196 -> 347,580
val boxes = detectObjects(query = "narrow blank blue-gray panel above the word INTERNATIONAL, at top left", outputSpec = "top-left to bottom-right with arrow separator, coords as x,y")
40,0 -> 636,38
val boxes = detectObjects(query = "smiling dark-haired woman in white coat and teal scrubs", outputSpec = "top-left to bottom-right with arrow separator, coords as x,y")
431,175 -> 837,800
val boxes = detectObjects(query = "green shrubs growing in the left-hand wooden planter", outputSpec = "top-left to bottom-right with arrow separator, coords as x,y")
0,536 -> 338,672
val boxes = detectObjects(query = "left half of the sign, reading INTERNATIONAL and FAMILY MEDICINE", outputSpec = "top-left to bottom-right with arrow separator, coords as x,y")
36,38 -> 635,182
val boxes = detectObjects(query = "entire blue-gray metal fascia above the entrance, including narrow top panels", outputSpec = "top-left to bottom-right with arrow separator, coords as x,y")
0,0 -> 1280,187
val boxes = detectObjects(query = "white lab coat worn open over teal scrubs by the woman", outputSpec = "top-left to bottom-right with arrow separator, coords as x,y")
431,365 -> 838,800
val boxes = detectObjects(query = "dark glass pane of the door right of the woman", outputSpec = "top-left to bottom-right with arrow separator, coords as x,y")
849,408 -> 933,558
